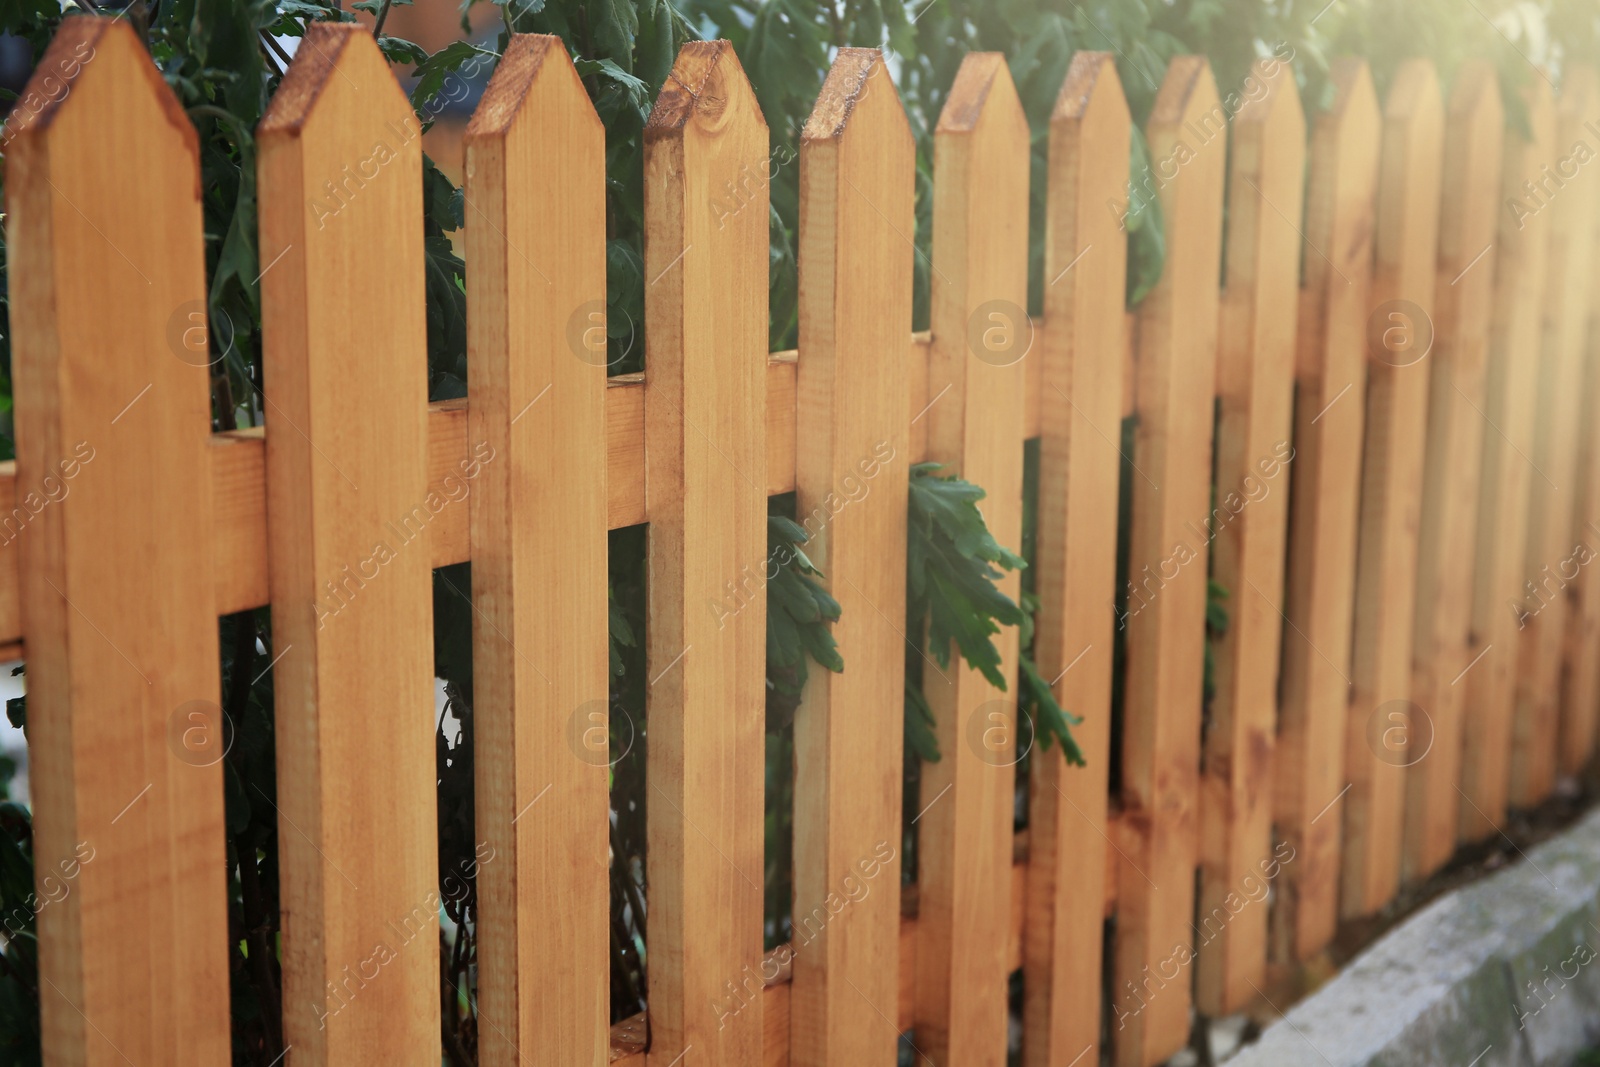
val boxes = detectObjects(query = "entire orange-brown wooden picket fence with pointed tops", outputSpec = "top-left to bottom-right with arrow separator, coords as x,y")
0,18 -> 1600,1067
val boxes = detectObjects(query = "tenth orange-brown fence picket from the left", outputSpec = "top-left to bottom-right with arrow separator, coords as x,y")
1267,59 -> 1379,960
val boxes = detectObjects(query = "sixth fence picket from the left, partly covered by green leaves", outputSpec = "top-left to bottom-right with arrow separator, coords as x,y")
915,53 -> 1034,1067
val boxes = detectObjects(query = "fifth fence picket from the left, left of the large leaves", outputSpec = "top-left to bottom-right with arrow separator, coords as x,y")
789,48 -> 917,1067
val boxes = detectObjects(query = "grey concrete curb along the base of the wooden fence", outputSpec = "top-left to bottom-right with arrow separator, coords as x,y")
1227,811 -> 1600,1067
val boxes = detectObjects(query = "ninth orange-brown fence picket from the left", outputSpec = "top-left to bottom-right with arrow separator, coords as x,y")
1195,59 -> 1306,1016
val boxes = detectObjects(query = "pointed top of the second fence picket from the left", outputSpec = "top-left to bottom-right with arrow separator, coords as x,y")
256,22 -> 414,139
